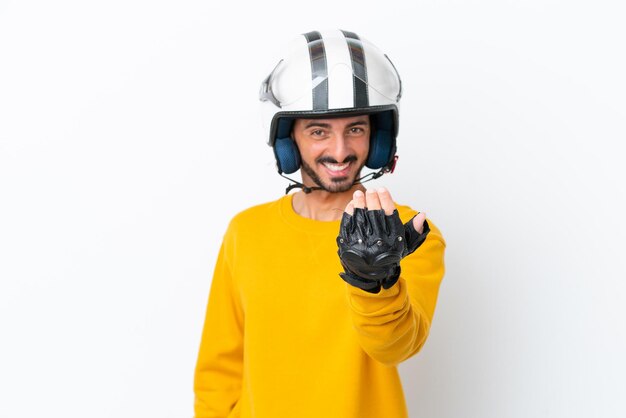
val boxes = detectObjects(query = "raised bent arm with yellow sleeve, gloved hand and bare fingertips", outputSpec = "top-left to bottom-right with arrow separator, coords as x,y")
338,189 -> 445,365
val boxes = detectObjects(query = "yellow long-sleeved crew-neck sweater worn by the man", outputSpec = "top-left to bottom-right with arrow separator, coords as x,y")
194,195 -> 445,418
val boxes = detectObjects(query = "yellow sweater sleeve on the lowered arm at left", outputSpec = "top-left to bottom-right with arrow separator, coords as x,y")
194,229 -> 244,418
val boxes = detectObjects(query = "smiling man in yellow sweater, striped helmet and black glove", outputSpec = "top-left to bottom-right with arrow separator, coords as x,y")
194,31 -> 445,418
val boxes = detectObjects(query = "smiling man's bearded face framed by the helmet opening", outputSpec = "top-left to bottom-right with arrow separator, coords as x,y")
292,115 -> 371,192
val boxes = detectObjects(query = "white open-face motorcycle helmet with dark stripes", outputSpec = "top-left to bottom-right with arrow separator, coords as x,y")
259,30 -> 402,175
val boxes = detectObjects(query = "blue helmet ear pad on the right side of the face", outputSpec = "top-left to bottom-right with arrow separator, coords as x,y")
365,111 -> 396,170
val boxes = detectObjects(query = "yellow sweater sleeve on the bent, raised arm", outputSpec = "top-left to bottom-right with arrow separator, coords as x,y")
346,220 -> 446,366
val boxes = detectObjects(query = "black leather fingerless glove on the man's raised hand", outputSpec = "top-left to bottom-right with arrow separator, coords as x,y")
337,208 -> 430,293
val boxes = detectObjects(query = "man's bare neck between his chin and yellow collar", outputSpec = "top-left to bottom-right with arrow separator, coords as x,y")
292,184 -> 365,221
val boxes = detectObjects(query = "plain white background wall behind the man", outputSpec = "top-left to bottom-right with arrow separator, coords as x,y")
0,0 -> 626,418
